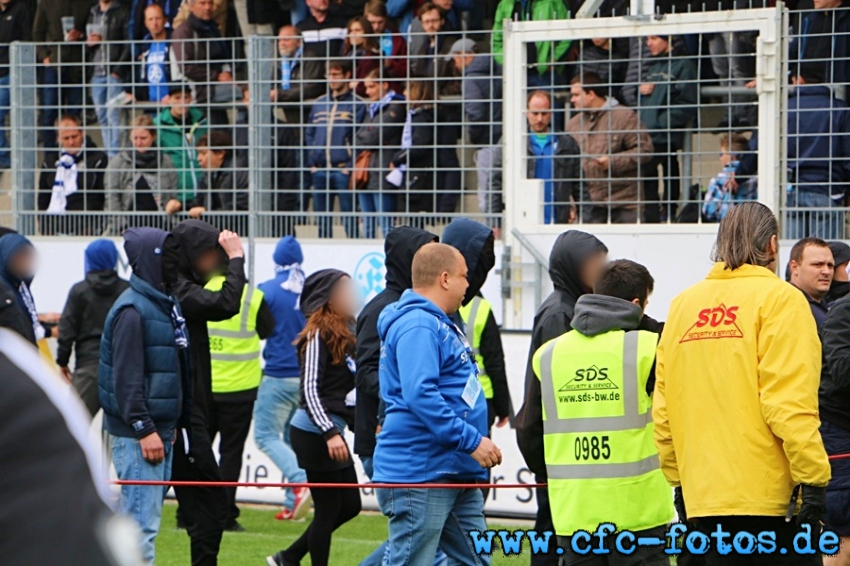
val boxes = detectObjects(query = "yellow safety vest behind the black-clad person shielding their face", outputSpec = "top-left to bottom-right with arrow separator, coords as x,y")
206,277 -> 263,393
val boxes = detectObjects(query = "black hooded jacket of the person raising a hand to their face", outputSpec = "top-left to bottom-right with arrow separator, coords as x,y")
172,220 -> 246,428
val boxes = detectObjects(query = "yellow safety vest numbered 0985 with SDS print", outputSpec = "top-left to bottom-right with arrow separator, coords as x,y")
533,330 -> 673,536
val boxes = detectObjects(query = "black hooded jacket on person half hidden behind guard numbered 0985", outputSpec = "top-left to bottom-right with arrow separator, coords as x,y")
516,230 -> 608,477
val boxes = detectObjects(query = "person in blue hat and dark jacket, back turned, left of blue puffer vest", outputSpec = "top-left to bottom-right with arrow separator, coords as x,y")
56,238 -> 130,417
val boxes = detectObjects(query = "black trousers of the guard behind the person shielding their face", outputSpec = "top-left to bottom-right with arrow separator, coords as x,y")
210,398 -> 256,528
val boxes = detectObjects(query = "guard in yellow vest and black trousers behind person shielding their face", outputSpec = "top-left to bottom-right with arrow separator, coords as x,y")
206,277 -> 275,531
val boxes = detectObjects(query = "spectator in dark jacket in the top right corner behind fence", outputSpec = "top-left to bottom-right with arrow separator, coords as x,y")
788,0 -> 850,102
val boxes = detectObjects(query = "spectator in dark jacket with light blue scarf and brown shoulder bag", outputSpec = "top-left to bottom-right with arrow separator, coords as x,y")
355,69 -> 407,239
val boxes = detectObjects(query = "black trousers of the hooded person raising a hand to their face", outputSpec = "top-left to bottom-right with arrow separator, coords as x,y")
171,423 -> 227,566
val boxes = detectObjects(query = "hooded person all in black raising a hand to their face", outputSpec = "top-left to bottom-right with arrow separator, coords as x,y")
166,219 -> 246,566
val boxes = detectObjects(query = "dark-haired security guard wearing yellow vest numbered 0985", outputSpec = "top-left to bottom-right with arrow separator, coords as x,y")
533,260 -> 673,566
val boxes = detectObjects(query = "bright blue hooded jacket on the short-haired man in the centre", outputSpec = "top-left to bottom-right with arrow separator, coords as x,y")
372,290 -> 487,483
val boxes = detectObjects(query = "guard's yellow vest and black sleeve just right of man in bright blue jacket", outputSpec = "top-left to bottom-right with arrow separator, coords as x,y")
458,296 -> 513,427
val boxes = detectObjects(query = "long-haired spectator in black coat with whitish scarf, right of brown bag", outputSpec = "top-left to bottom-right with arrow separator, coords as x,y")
387,81 -> 437,226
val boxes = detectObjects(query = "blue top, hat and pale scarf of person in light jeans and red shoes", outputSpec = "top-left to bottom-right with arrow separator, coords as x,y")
259,236 -> 306,379
